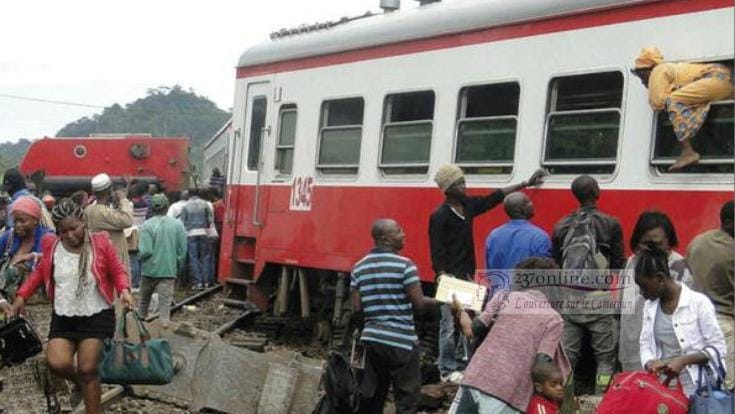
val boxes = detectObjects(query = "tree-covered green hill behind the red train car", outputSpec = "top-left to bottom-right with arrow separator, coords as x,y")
56,85 -> 230,169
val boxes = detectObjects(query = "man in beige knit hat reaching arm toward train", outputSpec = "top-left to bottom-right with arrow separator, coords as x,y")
429,164 -> 546,383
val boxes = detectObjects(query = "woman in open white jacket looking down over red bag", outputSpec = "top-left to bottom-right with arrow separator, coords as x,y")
635,243 -> 726,396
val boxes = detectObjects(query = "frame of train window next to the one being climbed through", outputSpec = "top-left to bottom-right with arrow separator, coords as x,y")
540,66 -> 628,173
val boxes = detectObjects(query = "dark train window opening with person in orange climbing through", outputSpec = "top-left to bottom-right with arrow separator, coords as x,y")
651,60 -> 735,174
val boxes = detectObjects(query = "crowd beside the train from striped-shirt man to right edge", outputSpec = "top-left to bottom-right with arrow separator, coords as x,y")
352,164 -> 735,414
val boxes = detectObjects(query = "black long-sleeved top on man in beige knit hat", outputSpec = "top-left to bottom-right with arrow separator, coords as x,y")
429,190 -> 505,280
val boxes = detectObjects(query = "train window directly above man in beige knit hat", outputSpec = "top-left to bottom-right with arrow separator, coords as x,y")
454,82 -> 521,174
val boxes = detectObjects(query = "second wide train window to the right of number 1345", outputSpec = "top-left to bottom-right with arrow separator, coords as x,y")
380,91 -> 434,174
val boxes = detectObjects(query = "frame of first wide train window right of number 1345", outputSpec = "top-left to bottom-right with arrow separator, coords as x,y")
314,95 -> 366,173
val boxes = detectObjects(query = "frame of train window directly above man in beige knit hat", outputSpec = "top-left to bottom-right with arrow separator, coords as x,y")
452,78 -> 523,172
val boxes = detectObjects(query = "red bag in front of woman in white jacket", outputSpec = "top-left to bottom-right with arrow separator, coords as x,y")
597,371 -> 689,414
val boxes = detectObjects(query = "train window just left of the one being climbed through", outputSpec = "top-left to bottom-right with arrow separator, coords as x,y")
543,71 -> 623,174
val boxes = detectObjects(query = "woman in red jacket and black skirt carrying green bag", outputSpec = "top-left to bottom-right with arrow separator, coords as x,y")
13,198 -> 133,413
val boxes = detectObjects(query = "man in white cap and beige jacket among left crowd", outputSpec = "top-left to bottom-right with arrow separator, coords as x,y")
84,173 -> 133,277
